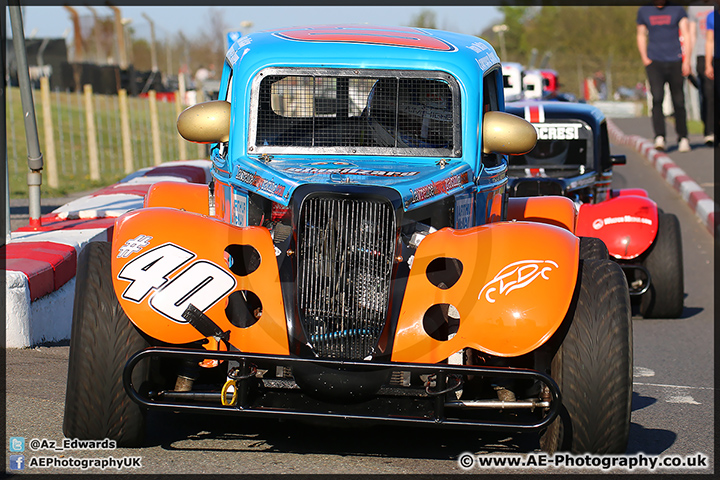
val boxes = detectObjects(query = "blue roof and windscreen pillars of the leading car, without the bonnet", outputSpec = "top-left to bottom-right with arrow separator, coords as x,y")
220,25 -> 503,167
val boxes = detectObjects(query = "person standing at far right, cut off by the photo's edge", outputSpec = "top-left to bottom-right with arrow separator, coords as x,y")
688,0 -> 715,145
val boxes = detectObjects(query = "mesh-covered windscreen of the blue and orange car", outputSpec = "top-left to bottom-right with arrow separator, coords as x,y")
255,75 -> 454,155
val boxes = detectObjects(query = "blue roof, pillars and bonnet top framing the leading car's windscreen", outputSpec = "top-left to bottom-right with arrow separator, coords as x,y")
214,25 -> 503,207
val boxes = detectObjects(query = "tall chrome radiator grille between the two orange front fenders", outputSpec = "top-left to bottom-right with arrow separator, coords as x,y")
297,193 -> 395,359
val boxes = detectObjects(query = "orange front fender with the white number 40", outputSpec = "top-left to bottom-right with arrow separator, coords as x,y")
112,207 -> 289,355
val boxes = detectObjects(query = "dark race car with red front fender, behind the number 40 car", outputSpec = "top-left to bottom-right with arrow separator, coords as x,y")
507,101 -> 684,318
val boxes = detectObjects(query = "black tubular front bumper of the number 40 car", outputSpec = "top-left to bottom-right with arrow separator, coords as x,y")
123,347 -> 561,431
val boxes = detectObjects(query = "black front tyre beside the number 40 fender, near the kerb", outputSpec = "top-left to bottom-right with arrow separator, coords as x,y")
63,242 -> 149,447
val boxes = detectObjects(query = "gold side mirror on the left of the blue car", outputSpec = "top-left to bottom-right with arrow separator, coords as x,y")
177,100 -> 230,143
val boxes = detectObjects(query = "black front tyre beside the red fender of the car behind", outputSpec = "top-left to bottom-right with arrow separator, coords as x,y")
640,213 -> 685,318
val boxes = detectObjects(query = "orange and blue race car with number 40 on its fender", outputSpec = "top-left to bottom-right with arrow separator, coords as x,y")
64,25 -> 632,453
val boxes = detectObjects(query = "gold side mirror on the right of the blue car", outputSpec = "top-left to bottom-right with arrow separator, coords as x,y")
482,112 -> 537,155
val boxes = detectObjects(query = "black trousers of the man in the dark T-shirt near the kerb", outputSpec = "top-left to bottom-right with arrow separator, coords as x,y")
645,62 -> 687,138
